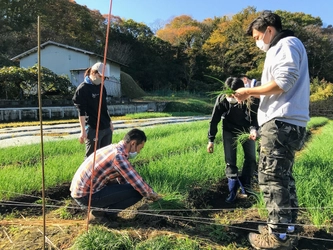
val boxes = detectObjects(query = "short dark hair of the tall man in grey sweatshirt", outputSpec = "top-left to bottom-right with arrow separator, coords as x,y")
246,10 -> 282,36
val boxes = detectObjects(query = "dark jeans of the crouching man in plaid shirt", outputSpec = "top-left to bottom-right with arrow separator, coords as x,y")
75,184 -> 142,214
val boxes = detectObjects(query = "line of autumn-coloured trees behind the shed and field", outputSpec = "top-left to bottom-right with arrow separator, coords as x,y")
0,0 -> 333,96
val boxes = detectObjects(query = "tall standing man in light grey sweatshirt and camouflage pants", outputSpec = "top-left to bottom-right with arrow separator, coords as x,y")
234,11 -> 310,249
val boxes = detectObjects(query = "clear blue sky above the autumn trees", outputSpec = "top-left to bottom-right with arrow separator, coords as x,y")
76,0 -> 333,27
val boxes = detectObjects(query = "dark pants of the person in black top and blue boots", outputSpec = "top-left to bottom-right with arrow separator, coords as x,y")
222,130 -> 256,186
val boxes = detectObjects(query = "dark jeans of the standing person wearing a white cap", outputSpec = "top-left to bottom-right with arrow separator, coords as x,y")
86,126 -> 112,158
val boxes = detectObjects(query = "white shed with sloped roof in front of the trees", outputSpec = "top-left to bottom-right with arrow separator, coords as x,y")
11,41 -> 126,97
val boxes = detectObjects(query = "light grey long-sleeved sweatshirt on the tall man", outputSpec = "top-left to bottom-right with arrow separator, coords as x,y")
258,36 -> 310,127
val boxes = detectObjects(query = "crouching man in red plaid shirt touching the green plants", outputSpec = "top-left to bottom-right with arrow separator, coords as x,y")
70,129 -> 160,226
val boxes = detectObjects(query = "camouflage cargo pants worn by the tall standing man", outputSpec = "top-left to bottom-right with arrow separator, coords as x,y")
259,119 -> 306,232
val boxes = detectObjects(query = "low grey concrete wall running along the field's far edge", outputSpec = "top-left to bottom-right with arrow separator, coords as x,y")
0,102 -> 166,122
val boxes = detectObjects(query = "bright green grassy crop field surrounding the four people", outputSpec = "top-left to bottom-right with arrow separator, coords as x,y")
0,117 -> 333,249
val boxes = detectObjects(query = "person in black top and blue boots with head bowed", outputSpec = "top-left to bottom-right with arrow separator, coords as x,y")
207,77 -> 259,203
